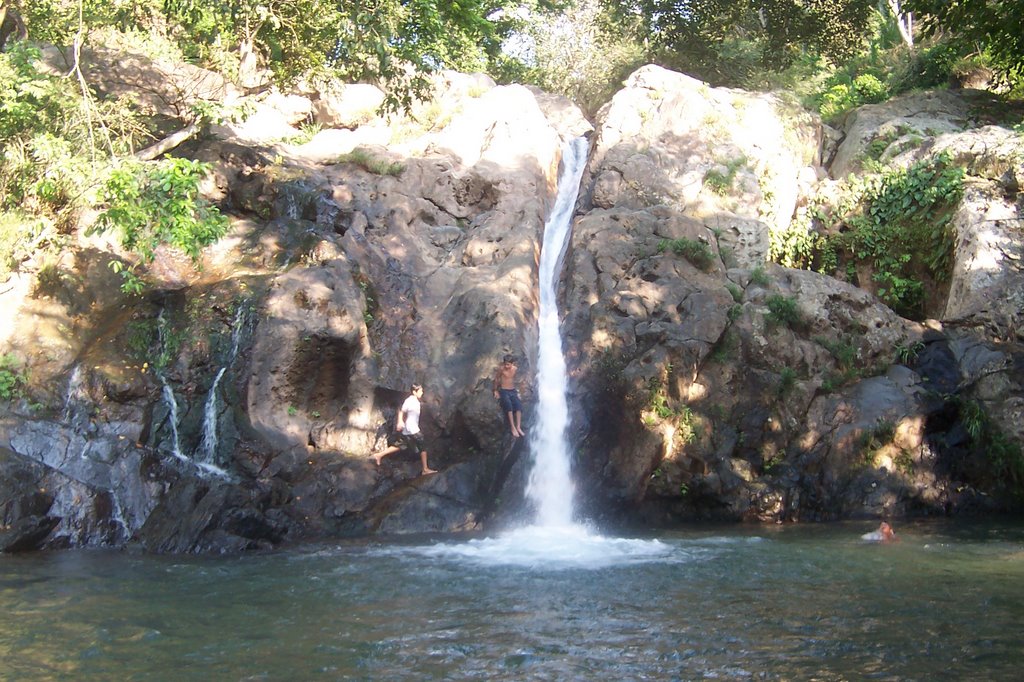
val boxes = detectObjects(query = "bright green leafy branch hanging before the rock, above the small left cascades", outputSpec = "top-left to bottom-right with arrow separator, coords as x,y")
91,159 -> 227,293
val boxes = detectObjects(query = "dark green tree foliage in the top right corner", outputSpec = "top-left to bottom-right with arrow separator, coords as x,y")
903,0 -> 1024,80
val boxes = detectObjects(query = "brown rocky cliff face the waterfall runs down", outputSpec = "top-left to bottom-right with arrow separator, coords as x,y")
0,53 -> 1024,552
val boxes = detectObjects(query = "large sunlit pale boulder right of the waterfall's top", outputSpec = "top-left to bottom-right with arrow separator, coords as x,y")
591,66 -> 821,266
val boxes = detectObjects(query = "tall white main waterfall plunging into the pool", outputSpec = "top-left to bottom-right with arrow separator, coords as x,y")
526,137 -> 588,526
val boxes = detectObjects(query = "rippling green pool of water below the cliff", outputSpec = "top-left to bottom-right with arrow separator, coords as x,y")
0,522 -> 1024,681
